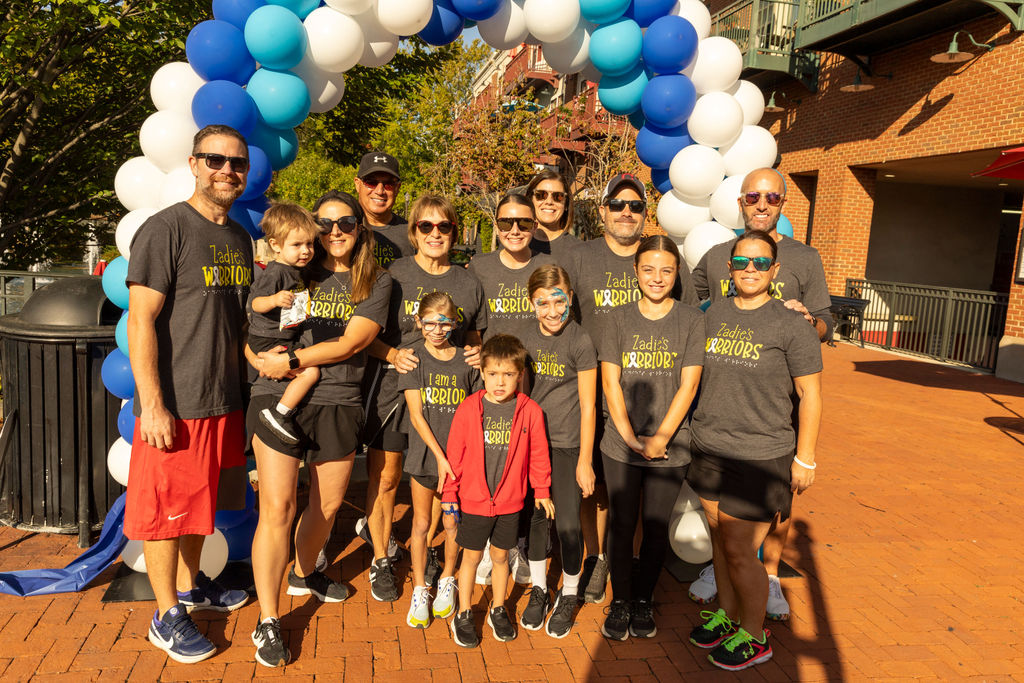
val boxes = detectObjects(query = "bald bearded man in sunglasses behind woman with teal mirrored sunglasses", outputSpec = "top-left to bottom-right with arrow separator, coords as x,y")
689,168 -> 833,621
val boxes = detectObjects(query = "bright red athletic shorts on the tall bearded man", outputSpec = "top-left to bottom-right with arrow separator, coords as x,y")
124,411 -> 246,541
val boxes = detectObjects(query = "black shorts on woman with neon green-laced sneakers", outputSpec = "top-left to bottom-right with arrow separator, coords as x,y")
686,447 -> 793,522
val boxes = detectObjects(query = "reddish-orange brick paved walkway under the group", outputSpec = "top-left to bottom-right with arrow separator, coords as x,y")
0,345 -> 1024,683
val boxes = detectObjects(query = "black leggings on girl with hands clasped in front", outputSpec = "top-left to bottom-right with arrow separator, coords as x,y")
601,454 -> 686,600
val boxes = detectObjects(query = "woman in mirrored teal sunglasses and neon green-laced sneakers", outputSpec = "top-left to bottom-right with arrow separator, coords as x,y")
689,230 -> 821,671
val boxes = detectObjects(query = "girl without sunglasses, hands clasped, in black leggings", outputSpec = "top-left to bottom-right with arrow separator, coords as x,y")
598,236 -> 705,640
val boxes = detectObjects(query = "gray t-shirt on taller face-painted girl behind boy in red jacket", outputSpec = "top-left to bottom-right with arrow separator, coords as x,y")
519,321 -> 597,449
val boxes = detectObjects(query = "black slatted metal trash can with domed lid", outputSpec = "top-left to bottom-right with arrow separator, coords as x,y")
0,276 -> 124,548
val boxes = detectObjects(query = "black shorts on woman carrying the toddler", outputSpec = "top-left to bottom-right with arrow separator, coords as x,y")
246,394 -> 362,465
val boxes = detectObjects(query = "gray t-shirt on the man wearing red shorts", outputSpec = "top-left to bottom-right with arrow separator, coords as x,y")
127,202 -> 253,420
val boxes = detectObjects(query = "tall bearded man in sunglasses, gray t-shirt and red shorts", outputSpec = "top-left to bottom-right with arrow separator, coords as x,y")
124,125 -> 253,664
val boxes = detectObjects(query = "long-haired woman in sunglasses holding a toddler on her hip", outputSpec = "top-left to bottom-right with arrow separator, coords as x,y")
246,190 -> 391,667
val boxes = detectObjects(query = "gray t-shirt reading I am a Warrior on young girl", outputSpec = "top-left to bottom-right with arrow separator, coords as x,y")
398,339 -> 483,476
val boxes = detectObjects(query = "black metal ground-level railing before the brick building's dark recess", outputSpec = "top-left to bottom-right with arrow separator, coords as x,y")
846,278 -> 1010,371
